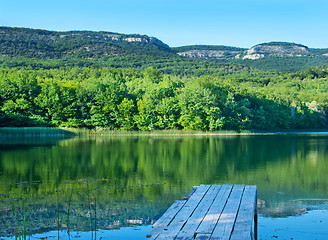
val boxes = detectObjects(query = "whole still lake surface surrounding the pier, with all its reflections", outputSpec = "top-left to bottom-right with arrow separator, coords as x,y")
0,133 -> 328,240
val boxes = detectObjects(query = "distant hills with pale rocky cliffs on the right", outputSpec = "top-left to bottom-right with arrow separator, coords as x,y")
173,42 -> 328,72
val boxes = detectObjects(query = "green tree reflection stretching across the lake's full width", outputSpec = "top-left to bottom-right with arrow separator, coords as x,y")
0,136 -> 328,197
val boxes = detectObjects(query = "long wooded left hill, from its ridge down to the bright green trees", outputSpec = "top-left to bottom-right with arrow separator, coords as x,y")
0,27 -> 249,75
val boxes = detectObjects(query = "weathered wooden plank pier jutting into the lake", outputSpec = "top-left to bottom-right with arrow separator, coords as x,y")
147,185 -> 257,240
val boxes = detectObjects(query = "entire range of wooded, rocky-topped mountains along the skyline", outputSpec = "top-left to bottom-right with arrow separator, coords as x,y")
0,27 -> 328,72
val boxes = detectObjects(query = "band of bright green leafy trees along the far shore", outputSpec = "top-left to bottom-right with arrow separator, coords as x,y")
0,66 -> 328,131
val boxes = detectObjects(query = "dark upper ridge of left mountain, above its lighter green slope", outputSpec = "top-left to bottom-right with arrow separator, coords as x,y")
0,27 -> 171,58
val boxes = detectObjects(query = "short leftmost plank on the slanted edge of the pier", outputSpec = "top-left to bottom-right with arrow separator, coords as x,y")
146,200 -> 187,238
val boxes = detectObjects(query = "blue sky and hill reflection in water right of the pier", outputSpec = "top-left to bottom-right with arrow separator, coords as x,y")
258,198 -> 328,240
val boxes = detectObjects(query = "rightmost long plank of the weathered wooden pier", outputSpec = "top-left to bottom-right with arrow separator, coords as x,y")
230,186 -> 257,240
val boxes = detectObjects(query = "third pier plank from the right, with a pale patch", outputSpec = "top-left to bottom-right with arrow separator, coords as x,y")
195,184 -> 233,234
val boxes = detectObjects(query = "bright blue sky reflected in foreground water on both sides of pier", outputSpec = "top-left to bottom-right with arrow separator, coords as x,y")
4,211 -> 328,240
